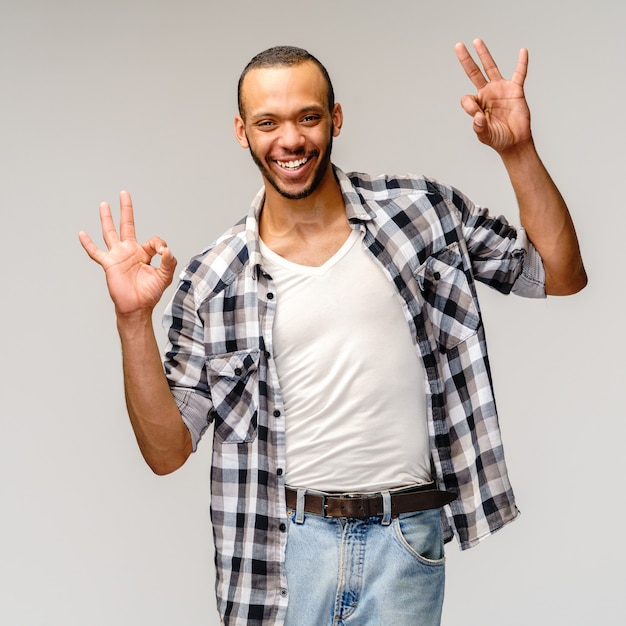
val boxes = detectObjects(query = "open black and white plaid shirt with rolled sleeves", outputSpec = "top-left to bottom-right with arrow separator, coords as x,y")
164,169 -> 544,625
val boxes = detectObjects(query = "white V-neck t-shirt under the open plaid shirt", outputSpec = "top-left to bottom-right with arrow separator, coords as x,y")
261,231 -> 430,492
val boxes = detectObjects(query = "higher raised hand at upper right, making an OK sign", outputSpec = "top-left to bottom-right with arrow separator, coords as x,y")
455,39 -> 532,155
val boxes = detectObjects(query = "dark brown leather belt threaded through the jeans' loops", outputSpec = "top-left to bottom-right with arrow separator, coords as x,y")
285,483 -> 457,519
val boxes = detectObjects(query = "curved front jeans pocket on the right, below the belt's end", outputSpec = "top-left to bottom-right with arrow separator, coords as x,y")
392,509 -> 445,565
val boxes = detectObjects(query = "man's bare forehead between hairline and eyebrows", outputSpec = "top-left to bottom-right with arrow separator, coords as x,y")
241,61 -> 328,115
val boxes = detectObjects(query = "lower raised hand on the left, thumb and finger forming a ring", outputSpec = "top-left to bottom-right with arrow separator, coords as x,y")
78,191 -> 176,315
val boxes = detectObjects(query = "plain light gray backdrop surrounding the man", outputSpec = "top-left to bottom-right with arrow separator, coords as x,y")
0,0 -> 626,626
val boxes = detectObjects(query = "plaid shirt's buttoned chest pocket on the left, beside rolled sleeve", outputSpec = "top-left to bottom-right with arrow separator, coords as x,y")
207,350 -> 260,443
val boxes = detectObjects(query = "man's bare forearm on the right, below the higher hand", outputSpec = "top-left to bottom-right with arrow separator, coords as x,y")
501,141 -> 587,295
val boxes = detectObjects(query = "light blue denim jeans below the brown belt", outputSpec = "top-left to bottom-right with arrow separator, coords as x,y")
285,494 -> 445,626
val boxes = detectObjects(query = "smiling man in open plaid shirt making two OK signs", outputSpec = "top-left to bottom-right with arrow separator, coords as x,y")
80,40 -> 586,626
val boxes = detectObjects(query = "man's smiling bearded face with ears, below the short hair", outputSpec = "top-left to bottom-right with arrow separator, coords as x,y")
235,61 -> 343,200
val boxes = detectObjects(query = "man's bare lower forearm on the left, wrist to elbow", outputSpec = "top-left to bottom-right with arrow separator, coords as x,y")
118,314 -> 192,474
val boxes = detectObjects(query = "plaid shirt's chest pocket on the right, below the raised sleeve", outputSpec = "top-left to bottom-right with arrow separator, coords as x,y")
415,243 -> 480,351
